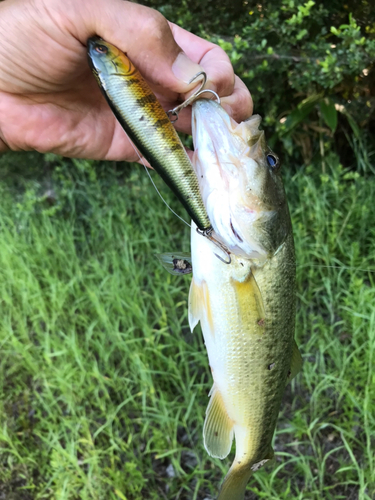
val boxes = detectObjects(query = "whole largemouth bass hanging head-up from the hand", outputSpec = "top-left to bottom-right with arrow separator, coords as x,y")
189,99 -> 301,500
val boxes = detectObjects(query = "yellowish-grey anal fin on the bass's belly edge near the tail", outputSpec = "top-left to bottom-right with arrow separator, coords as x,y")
203,384 -> 233,458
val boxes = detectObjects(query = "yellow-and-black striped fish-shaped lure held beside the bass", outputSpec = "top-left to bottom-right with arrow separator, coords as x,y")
87,36 -> 211,232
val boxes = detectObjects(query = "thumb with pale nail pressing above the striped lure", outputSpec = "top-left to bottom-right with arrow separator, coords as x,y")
71,0 -> 203,94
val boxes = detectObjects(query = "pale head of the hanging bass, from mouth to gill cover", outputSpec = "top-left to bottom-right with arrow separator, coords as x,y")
192,99 -> 287,260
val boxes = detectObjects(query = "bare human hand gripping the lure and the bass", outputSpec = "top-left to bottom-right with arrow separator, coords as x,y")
0,0 -> 252,161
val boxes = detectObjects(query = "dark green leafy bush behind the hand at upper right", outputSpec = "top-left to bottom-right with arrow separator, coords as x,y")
142,0 -> 375,167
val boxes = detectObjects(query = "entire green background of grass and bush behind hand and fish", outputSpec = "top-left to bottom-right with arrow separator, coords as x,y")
0,0 -> 375,500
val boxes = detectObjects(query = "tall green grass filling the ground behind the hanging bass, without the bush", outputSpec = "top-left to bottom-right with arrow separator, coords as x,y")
0,150 -> 375,500
